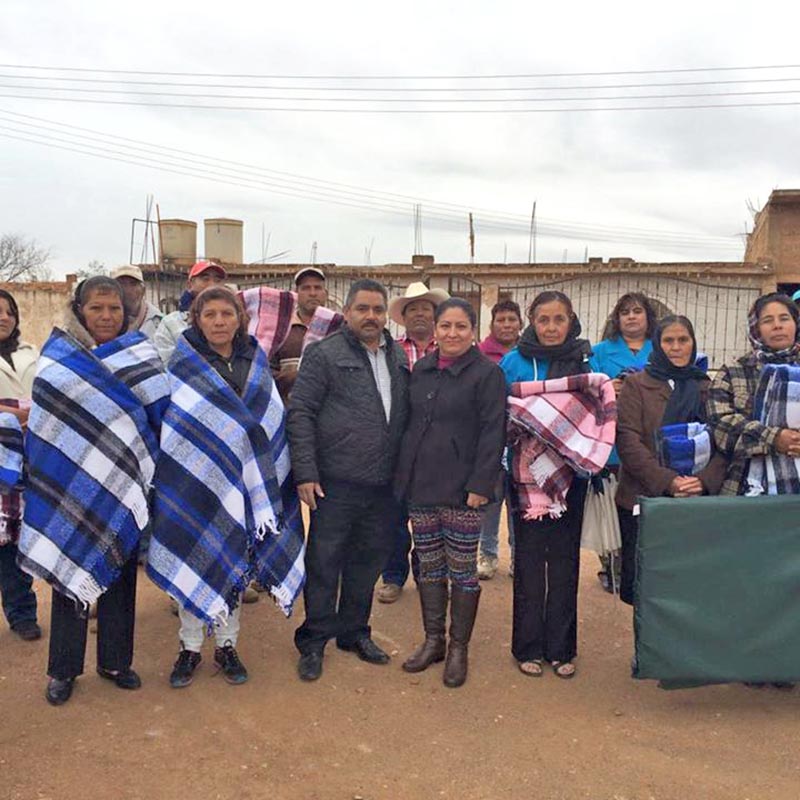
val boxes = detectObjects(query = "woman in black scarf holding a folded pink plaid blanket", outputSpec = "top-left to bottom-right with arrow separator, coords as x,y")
500,291 -> 614,678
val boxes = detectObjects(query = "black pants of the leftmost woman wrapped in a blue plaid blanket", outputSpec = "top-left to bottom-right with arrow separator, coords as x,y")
47,553 -> 137,680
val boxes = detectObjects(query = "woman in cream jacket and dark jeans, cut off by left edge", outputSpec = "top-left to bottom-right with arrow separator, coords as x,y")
0,290 -> 42,641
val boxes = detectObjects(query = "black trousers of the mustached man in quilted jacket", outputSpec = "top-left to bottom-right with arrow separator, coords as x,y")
294,481 -> 399,653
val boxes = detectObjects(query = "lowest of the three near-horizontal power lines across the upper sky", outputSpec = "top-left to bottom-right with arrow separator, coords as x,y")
0,94 -> 800,114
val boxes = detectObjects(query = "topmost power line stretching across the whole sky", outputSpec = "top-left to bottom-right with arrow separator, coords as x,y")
0,64 -> 800,81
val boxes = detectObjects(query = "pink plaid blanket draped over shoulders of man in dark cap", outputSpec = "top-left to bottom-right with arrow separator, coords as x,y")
234,286 -> 343,358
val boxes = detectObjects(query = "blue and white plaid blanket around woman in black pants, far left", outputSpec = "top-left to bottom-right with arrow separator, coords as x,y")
19,328 -> 169,605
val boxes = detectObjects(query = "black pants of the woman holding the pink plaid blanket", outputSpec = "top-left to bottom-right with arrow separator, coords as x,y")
511,479 -> 586,661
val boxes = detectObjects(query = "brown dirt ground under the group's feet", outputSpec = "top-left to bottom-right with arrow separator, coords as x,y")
0,528 -> 800,800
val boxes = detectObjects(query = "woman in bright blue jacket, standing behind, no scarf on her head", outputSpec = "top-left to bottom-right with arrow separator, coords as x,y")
587,292 -> 656,593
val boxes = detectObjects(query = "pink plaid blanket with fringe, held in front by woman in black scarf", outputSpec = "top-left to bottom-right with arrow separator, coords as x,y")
508,373 -> 617,519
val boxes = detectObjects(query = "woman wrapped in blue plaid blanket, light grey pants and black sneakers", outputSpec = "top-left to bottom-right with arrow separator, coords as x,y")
147,286 -> 305,689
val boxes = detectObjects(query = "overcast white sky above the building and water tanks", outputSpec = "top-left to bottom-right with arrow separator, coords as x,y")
0,0 -> 800,275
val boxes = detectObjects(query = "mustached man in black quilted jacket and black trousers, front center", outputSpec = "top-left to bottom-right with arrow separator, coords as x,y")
288,279 -> 408,681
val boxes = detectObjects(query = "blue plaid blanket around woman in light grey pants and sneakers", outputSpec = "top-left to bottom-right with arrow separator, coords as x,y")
147,337 -> 305,624
